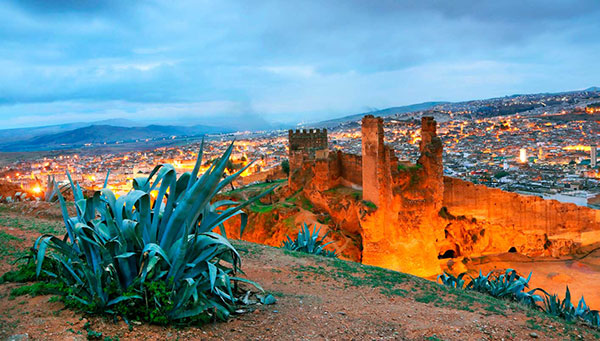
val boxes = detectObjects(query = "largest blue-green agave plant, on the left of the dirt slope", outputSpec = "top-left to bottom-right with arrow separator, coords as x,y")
33,141 -> 274,323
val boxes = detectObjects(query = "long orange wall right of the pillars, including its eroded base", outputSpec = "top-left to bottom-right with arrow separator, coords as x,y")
443,177 -> 600,256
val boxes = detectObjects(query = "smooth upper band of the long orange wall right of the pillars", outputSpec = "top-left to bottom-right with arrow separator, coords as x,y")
443,176 -> 600,245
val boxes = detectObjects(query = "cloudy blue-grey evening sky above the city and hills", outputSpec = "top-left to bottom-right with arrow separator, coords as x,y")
0,0 -> 600,129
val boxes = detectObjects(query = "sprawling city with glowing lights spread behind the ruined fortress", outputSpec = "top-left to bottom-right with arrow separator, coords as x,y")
0,91 -> 600,208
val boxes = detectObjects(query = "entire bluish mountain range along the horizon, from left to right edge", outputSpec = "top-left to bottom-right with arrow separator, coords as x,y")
0,87 -> 600,152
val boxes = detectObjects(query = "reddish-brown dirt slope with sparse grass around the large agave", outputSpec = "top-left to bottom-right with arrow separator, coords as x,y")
0,204 -> 600,340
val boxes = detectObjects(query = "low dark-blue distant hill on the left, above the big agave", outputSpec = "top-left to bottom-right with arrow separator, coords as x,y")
0,124 -> 231,151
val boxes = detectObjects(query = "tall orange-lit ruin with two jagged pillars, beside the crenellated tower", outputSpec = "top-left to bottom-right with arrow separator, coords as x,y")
361,117 -> 444,277
